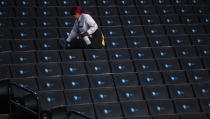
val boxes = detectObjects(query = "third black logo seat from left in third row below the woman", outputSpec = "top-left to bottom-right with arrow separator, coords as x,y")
63,75 -> 89,89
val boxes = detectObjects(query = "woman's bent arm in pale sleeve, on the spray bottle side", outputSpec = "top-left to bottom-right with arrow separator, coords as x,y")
85,14 -> 98,35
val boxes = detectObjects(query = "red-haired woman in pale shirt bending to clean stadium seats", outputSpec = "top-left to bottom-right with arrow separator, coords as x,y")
66,6 -> 105,49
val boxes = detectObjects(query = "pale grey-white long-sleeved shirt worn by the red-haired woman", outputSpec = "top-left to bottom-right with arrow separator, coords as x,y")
67,14 -> 98,42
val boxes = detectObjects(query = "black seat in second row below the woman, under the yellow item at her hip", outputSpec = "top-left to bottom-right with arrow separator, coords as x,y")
85,61 -> 110,74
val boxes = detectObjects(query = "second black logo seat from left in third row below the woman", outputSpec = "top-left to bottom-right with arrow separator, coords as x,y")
37,77 -> 64,91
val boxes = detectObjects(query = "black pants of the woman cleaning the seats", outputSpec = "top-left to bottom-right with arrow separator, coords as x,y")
70,29 -> 103,49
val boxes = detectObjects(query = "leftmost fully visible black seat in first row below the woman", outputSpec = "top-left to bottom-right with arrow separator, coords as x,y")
12,52 -> 36,63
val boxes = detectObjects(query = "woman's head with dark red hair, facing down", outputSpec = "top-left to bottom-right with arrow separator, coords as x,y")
71,6 -> 87,19
